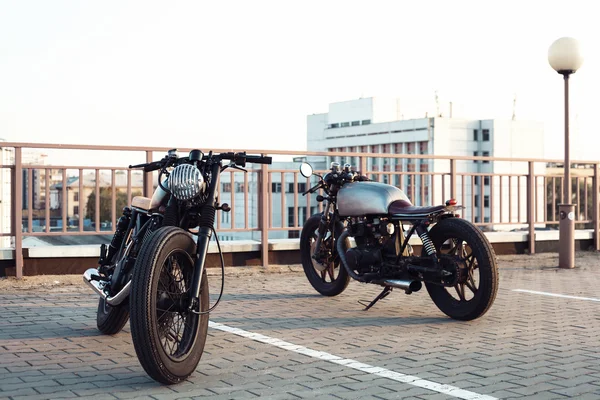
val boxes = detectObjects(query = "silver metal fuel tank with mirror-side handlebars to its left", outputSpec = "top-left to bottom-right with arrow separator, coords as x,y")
337,182 -> 410,217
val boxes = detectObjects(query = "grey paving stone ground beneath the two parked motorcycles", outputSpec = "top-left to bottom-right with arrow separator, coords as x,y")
0,256 -> 600,400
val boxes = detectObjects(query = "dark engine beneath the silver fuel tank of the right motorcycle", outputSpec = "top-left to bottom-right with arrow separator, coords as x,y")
346,218 -> 395,274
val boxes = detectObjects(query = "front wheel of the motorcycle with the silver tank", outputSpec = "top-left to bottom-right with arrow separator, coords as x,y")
300,214 -> 350,296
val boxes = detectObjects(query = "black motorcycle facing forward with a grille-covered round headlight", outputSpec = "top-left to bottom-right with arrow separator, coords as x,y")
83,150 -> 271,384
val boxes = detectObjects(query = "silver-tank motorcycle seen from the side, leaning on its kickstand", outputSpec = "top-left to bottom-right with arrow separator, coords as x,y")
300,162 -> 498,321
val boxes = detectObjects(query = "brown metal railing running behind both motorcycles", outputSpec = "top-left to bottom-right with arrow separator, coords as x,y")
0,142 -> 600,277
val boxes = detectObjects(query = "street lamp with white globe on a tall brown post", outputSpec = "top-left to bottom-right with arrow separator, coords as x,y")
548,37 -> 583,268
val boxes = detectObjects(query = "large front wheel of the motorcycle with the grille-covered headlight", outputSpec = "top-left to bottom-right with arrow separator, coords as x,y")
130,226 -> 209,384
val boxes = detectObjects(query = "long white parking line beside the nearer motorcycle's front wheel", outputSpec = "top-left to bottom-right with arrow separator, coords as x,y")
208,321 -> 497,400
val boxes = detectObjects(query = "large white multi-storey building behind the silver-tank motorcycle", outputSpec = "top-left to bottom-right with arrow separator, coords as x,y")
307,98 -> 545,229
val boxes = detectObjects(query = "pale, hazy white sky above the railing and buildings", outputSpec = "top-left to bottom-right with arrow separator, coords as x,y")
0,0 -> 600,164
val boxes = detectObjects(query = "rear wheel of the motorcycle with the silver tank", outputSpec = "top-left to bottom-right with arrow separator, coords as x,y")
423,218 -> 498,321
